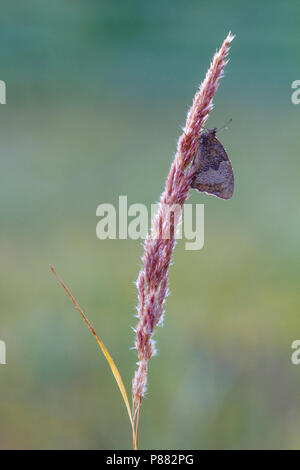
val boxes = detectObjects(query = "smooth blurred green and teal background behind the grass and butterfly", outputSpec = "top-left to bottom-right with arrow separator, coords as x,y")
0,0 -> 300,449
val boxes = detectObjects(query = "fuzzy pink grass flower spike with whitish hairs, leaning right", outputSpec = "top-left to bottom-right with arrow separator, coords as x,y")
132,33 -> 234,428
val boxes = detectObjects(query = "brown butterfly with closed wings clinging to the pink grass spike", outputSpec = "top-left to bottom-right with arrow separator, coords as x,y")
191,128 -> 234,199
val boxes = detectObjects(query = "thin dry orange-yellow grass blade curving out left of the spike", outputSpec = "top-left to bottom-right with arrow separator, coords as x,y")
50,264 -> 137,448
